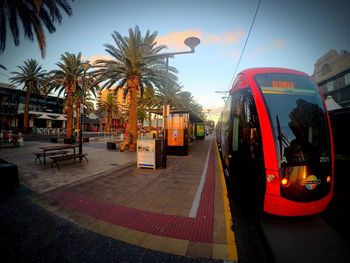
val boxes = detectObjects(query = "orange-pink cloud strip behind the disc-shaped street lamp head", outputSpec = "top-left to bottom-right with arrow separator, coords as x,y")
157,29 -> 245,50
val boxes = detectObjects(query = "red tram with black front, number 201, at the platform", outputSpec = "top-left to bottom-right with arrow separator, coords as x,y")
216,68 -> 334,216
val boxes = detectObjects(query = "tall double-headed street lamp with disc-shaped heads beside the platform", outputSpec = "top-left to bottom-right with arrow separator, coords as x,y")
139,37 -> 201,168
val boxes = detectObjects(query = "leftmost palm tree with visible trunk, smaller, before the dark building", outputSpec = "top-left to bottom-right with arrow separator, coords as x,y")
10,59 -> 46,133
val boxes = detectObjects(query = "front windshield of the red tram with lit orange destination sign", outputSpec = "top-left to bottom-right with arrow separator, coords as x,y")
255,73 -> 330,167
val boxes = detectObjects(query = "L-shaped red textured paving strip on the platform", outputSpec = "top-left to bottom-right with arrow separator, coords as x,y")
46,144 -> 215,243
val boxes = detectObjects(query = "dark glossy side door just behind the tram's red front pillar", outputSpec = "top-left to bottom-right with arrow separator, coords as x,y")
229,88 -> 265,206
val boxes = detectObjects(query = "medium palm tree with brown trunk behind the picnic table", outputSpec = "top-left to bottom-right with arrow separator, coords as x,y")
50,52 -> 84,139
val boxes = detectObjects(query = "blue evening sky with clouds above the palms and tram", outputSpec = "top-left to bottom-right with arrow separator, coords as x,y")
0,0 -> 350,123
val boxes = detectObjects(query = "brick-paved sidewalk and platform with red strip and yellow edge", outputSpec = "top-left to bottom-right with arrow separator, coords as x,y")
0,140 -> 237,261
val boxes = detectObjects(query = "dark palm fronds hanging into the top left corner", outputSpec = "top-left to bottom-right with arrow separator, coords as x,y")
0,0 -> 72,58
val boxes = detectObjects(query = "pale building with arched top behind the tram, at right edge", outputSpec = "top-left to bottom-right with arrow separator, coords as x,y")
312,49 -> 350,107
